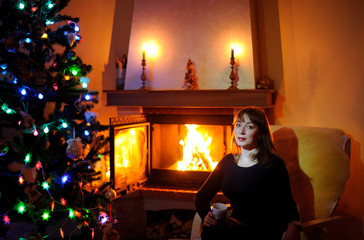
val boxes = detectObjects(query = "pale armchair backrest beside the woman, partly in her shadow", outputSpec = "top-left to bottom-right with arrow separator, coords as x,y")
271,125 -> 350,221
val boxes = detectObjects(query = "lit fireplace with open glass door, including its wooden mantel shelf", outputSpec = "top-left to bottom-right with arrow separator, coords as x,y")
107,90 -> 273,193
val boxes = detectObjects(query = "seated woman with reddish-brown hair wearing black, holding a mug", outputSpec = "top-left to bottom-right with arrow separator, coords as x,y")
195,108 -> 300,240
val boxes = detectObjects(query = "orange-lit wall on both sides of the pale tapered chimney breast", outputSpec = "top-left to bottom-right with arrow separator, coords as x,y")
64,0 -> 364,240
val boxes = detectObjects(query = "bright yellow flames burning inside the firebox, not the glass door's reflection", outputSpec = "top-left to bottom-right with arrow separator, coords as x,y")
177,124 -> 217,171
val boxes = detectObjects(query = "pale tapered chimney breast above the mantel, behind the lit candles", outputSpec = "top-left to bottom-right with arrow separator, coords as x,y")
126,0 -> 254,89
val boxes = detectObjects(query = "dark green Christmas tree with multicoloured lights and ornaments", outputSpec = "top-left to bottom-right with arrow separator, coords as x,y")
0,0 -> 116,239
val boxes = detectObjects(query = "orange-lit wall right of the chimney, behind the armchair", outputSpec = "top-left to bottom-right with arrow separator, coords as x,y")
265,0 -> 364,239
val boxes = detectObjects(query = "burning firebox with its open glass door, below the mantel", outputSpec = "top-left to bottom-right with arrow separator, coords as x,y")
110,114 -> 232,191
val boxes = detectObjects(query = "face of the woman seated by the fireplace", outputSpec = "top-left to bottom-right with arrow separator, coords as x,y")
234,114 -> 260,150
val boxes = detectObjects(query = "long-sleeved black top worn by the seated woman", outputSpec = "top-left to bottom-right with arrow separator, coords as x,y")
195,154 -> 299,232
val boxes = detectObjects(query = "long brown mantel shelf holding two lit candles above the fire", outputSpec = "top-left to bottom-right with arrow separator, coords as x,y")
104,89 -> 274,108
